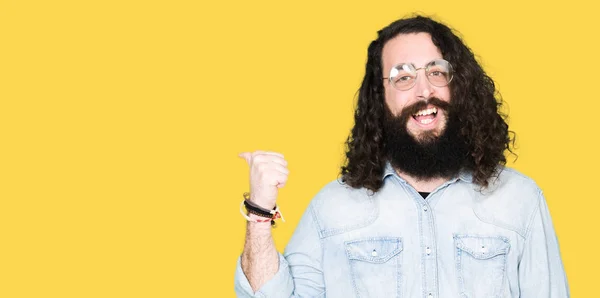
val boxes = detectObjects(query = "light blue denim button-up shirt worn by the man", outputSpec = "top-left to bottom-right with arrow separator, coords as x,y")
235,164 -> 569,298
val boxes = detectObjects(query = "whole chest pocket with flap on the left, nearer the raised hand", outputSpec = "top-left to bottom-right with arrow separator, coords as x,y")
345,237 -> 403,297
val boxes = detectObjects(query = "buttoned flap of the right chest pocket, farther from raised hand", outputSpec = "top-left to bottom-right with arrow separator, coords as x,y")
454,235 -> 510,260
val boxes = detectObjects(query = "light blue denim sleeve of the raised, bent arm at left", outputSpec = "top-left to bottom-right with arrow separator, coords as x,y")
235,201 -> 325,298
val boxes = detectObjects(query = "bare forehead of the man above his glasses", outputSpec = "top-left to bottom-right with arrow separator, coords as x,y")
381,33 -> 443,73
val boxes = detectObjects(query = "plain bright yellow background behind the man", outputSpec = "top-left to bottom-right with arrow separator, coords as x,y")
0,0 -> 600,297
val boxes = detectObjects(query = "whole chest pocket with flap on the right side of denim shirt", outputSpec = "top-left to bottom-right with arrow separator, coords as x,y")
454,235 -> 510,298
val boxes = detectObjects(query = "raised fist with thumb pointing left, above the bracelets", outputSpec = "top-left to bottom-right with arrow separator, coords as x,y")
239,151 -> 289,209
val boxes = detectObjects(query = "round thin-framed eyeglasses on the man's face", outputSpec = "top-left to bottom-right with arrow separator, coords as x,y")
383,59 -> 454,91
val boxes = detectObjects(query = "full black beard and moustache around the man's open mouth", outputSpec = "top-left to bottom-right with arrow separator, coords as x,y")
383,98 -> 469,181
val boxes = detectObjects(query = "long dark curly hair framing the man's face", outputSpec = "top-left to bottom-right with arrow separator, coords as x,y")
341,15 -> 515,192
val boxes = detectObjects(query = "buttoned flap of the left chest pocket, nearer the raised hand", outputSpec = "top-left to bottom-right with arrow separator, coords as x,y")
345,237 -> 402,263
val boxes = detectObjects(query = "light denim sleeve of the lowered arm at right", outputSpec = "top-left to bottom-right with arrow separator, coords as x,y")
519,191 -> 570,298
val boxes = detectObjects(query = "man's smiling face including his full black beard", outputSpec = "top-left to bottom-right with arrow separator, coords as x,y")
382,33 -> 469,180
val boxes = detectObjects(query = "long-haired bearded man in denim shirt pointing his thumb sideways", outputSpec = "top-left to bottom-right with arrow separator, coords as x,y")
235,16 -> 569,298
